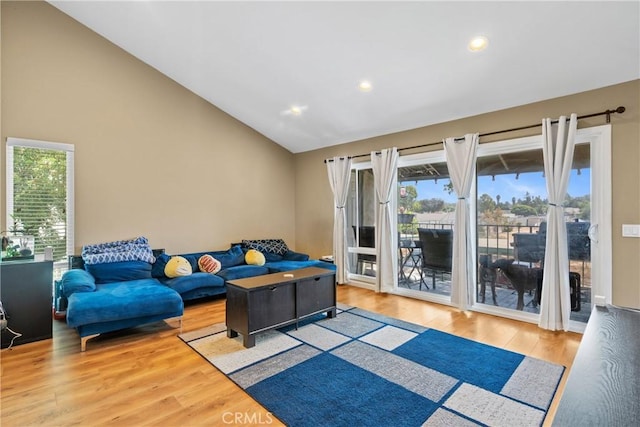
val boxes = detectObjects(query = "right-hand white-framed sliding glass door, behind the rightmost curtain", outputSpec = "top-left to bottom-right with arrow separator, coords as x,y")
475,127 -> 611,329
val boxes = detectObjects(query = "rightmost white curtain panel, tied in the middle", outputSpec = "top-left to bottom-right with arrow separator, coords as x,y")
538,114 -> 578,331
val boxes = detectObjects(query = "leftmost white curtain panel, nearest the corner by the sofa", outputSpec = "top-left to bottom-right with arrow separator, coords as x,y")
327,157 -> 351,283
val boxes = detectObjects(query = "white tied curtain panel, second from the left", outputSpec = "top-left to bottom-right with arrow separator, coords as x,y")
371,147 -> 398,292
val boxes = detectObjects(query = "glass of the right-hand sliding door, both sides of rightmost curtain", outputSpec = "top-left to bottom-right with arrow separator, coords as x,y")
476,143 -> 591,321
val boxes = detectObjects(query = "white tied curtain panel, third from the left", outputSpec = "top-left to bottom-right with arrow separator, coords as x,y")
444,133 -> 479,310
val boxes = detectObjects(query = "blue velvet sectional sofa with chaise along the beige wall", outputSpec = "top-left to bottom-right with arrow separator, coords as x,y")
60,239 -> 335,351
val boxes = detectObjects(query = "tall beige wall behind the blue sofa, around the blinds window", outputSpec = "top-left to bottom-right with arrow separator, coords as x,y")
0,1 -> 295,253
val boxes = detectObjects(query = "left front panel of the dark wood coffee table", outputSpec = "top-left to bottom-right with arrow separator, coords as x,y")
248,283 -> 296,332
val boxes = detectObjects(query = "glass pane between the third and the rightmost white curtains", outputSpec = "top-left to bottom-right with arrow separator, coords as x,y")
476,148 -> 548,314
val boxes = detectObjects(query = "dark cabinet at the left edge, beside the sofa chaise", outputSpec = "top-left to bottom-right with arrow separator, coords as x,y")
0,261 -> 53,348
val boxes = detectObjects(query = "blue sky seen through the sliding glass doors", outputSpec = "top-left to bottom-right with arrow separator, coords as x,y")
405,169 -> 591,203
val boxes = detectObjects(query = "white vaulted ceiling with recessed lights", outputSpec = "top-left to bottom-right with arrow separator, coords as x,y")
49,1 -> 640,153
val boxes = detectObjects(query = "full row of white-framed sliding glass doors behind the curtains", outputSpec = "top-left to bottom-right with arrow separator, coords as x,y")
347,125 -> 612,330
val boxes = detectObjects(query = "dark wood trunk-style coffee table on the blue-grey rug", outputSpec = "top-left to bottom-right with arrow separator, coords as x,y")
226,267 -> 336,347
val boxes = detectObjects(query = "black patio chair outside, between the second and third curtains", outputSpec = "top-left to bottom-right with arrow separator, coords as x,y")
418,228 -> 453,289
